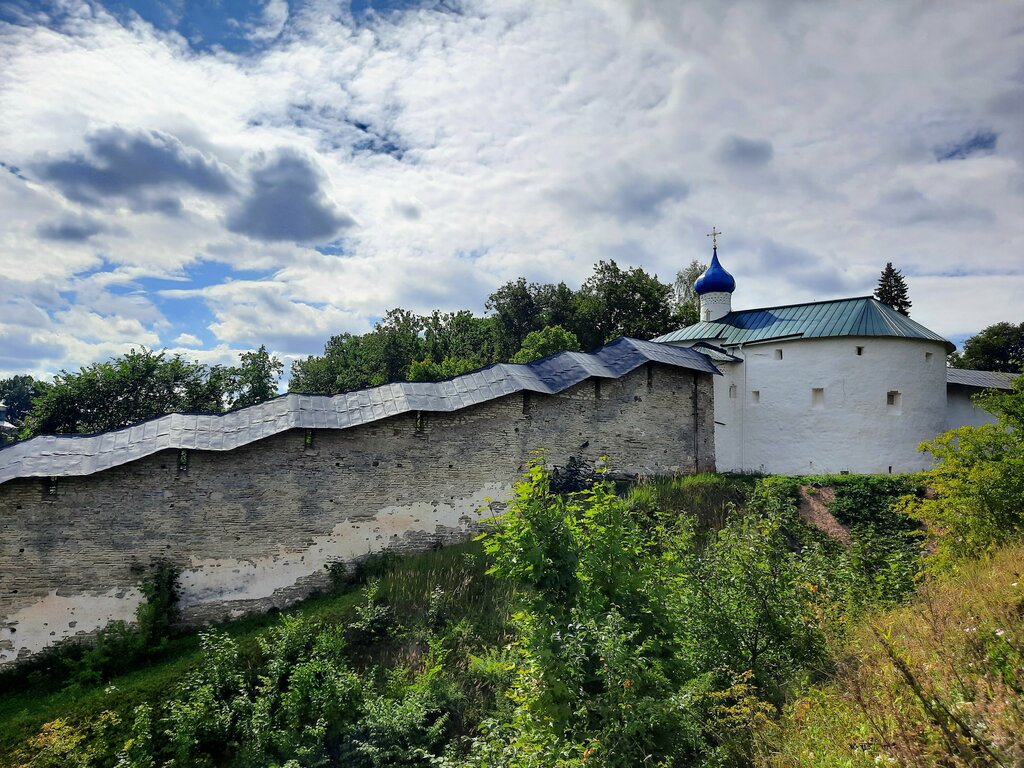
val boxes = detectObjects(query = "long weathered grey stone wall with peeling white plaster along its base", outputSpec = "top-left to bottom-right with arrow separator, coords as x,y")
0,364 -> 715,665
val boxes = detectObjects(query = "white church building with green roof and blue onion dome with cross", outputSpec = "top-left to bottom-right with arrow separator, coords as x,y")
654,246 -> 1013,474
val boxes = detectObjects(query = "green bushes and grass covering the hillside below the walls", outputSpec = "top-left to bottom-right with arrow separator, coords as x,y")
0,376 -> 1024,768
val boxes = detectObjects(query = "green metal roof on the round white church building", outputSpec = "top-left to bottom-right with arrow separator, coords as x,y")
654,296 -> 956,352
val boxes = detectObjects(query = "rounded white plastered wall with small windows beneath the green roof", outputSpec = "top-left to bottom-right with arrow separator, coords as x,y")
700,337 -> 947,474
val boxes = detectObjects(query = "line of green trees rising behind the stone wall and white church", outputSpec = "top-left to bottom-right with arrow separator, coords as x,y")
0,260 -> 1024,442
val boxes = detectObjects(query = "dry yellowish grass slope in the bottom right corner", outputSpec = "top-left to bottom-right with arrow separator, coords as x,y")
759,545 -> 1024,768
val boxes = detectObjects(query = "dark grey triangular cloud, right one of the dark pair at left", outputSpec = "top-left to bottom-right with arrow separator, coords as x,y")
227,150 -> 355,243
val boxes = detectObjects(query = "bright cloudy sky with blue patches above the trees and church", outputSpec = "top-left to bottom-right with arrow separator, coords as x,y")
0,0 -> 1024,377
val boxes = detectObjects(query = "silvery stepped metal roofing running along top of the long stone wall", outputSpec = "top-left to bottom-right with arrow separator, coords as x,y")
0,338 -> 720,483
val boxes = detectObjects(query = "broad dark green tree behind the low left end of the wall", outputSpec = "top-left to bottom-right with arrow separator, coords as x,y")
22,347 -> 226,437
